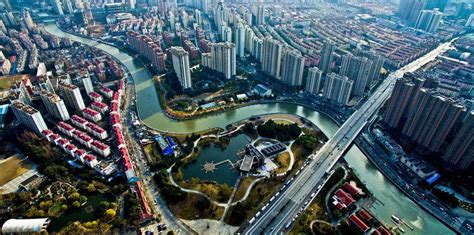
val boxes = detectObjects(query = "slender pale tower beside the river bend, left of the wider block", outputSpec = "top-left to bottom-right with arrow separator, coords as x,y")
170,47 -> 192,89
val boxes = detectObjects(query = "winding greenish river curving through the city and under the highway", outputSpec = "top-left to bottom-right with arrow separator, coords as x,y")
45,24 -> 454,235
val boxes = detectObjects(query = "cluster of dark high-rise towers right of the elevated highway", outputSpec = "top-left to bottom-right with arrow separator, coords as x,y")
383,74 -> 474,169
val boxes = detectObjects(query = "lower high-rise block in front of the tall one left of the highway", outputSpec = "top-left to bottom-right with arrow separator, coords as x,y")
323,73 -> 354,105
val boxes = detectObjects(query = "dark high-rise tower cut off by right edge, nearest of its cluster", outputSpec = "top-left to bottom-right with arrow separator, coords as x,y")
443,111 -> 474,169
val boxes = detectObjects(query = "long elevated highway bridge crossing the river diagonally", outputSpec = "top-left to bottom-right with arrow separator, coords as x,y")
243,39 -> 455,234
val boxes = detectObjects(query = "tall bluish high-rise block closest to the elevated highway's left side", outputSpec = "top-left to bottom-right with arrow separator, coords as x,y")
339,54 -> 372,97
